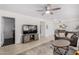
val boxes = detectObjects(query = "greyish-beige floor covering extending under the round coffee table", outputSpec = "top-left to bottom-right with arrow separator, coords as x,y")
21,42 -> 75,55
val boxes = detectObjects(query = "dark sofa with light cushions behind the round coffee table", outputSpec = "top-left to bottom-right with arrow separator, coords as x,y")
54,30 -> 78,47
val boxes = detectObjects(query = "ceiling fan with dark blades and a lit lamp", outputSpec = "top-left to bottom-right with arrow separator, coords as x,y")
37,4 -> 61,15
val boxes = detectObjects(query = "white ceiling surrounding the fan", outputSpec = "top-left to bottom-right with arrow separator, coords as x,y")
0,4 -> 79,20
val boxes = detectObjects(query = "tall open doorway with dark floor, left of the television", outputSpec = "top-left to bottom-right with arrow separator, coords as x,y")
2,17 -> 15,46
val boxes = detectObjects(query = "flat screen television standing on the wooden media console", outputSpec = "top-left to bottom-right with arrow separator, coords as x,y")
22,25 -> 37,34
